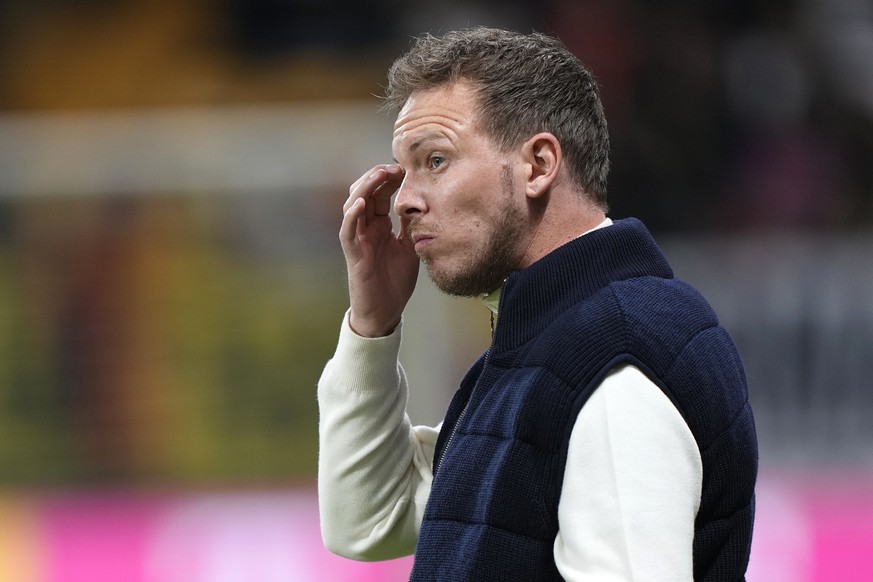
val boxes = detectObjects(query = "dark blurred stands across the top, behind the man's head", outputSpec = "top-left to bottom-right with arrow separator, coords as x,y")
0,0 -> 873,231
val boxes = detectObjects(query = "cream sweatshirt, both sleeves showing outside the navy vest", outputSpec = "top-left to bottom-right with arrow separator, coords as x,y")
318,314 -> 703,582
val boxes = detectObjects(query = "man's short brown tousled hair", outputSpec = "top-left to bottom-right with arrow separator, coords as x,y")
384,27 -> 609,210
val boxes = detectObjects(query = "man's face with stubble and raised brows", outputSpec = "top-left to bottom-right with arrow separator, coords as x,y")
392,83 -> 527,297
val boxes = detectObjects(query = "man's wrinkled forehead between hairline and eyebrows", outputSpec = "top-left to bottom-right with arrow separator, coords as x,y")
392,82 -> 477,155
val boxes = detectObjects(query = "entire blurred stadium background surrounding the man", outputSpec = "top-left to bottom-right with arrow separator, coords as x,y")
0,0 -> 873,582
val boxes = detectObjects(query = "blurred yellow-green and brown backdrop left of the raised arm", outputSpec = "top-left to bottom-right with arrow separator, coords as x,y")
0,197 -> 342,483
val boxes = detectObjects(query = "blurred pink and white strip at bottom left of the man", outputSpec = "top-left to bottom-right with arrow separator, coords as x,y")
0,490 -> 411,582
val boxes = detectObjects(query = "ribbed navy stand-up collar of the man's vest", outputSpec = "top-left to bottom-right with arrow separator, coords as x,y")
492,218 -> 673,351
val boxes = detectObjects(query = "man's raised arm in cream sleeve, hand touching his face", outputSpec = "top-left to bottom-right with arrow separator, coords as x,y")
318,164 -> 436,560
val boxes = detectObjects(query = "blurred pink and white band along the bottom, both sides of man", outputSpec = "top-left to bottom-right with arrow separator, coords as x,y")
0,471 -> 873,582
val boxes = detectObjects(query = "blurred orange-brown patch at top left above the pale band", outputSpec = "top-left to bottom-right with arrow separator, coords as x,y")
0,0 -> 385,110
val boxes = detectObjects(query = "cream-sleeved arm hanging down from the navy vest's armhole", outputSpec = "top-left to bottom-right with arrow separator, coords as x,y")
555,366 -> 703,582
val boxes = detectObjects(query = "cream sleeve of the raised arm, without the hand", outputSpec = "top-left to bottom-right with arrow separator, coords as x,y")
318,313 -> 439,560
